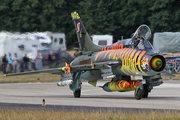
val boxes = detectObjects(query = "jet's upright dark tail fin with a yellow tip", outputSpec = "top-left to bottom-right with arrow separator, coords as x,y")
71,12 -> 101,52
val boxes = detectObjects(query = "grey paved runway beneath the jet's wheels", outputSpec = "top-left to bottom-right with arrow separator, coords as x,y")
0,80 -> 180,111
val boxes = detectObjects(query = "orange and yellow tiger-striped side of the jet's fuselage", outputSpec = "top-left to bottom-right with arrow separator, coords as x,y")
93,48 -> 150,75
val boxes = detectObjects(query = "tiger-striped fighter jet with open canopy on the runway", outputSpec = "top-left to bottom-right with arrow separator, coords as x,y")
5,12 -> 173,100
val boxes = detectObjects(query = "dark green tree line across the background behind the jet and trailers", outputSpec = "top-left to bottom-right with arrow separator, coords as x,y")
0,0 -> 180,46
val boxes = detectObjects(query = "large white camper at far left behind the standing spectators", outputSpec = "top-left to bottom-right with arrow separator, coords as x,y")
0,32 -> 41,58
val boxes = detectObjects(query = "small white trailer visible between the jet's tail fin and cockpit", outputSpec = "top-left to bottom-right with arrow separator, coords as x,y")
91,35 -> 113,46
